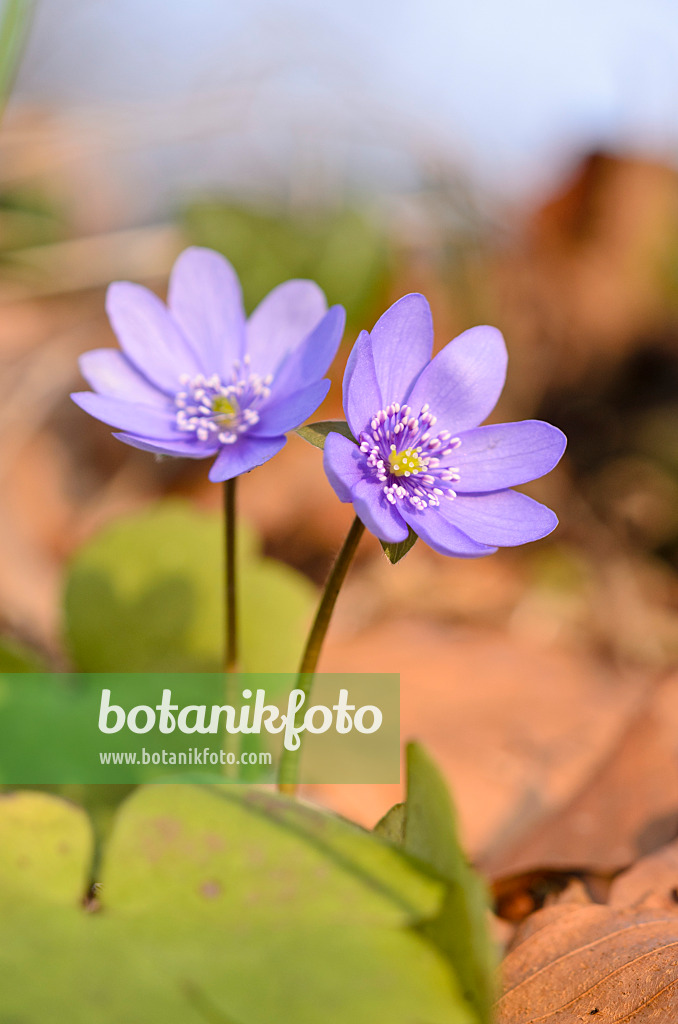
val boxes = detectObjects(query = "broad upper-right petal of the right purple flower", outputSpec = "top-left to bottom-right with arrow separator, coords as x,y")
408,327 -> 508,434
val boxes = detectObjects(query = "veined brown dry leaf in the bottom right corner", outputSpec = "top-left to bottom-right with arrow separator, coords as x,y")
497,903 -> 678,1024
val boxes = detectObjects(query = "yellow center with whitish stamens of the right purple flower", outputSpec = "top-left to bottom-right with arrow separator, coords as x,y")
358,402 -> 461,511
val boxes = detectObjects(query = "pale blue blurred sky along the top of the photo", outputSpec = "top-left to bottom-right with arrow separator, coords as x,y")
9,0 -> 678,205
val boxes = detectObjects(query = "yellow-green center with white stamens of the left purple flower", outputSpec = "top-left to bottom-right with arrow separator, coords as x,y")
174,356 -> 272,444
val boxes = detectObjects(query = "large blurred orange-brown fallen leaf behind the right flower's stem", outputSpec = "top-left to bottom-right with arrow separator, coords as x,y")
305,622 -> 646,856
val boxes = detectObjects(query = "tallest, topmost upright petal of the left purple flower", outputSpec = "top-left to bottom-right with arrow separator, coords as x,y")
167,246 -> 245,377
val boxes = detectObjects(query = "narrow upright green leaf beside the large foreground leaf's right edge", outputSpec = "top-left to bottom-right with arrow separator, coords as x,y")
404,743 -> 497,1024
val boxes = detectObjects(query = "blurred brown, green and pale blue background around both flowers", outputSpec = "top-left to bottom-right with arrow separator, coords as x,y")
0,0 -> 678,888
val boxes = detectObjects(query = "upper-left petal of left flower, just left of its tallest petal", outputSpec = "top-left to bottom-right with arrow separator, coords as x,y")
105,281 -> 203,395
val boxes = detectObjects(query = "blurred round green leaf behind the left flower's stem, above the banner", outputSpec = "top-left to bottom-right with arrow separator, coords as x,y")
65,501 -> 315,672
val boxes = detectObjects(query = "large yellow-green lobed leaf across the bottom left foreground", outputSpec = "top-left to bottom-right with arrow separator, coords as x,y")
0,786 -> 483,1024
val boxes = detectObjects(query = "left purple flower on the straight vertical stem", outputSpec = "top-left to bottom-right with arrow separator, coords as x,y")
72,248 -> 344,480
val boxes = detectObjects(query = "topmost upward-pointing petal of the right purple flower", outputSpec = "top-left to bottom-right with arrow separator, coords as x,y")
370,292 -> 433,403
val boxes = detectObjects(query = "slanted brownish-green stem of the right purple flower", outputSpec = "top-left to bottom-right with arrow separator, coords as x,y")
278,516 -> 365,795
